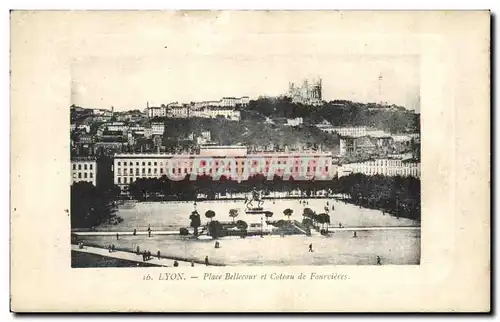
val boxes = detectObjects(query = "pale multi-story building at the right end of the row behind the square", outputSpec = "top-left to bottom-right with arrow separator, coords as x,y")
338,158 -> 420,178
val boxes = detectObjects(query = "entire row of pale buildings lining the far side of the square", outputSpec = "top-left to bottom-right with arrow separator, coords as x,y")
71,146 -> 420,189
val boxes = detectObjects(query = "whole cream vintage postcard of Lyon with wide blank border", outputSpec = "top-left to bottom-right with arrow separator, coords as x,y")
11,11 -> 490,312
